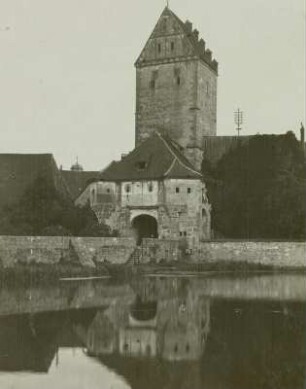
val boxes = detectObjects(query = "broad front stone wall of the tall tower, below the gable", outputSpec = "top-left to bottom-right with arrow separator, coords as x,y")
136,61 -> 198,147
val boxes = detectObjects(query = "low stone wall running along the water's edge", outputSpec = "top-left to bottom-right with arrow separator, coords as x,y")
0,236 -> 306,269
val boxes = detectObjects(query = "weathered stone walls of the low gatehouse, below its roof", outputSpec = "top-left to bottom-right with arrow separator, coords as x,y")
79,179 -> 211,247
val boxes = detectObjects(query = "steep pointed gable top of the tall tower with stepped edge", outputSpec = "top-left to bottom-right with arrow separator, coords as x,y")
135,7 -> 218,73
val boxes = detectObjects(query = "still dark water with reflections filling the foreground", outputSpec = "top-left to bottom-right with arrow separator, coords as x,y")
0,274 -> 306,389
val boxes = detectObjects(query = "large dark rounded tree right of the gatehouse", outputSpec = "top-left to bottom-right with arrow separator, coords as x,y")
204,132 -> 306,239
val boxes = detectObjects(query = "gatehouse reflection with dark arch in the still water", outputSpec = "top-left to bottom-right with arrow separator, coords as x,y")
75,279 -> 210,361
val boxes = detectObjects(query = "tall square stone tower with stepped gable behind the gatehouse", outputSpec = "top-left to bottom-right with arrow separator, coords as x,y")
135,7 -> 218,168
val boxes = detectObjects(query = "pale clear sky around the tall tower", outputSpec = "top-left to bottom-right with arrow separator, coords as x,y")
0,0 -> 305,170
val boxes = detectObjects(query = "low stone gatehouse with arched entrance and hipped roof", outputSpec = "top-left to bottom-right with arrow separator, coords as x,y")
76,133 -> 211,246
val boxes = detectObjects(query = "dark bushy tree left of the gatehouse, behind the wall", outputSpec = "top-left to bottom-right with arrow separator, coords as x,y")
0,176 -> 110,236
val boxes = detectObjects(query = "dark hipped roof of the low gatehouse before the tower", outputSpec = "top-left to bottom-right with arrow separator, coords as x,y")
99,132 -> 202,181
